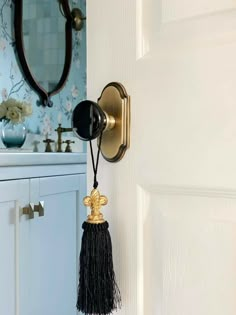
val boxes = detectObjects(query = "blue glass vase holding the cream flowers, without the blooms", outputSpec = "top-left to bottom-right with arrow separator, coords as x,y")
1,120 -> 27,148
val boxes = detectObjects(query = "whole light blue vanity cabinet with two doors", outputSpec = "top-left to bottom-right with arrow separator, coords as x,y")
0,154 -> 86,315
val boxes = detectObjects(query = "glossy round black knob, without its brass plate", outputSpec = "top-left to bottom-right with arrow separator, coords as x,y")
72,100 -> 107,141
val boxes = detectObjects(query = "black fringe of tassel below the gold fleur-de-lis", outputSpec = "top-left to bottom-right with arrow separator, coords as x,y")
77,221 -> 121,315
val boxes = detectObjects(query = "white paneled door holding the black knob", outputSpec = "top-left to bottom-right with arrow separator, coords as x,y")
87,0 -> 236,315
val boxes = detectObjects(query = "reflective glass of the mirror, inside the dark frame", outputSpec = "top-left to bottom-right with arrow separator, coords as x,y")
22,0 -> 66,91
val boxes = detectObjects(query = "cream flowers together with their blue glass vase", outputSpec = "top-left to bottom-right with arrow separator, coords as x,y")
0,98 -> 32,148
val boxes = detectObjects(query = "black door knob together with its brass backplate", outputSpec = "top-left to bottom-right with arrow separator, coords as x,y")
72,82 -> 130,162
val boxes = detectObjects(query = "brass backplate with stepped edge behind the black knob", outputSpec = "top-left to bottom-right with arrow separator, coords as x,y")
98,82 -> 130,162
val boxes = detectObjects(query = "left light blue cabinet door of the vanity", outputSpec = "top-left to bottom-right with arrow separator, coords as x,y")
0,180 -> 29,315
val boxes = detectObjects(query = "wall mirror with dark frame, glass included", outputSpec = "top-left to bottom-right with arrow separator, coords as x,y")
14,0 -> 81,107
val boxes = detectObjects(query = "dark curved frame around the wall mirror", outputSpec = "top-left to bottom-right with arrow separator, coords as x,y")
14,0 -> 73,107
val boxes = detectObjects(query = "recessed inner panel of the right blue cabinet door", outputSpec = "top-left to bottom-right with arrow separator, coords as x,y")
30,192 -> 76,315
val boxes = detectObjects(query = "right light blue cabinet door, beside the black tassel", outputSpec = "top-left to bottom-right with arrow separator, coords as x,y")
21,175 -> 86,315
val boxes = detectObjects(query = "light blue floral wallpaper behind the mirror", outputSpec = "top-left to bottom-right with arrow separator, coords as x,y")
0,0 -> 86,151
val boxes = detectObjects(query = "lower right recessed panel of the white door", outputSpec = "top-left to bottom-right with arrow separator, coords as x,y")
139,187 -> 236,315
